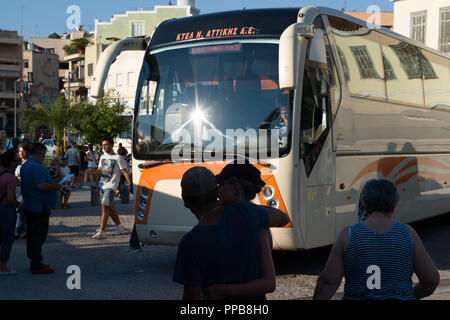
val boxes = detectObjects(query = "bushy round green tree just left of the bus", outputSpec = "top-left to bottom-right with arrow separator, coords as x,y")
71,90 -> 130,144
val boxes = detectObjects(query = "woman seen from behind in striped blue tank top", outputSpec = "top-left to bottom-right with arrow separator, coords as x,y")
314,179 -> 439,300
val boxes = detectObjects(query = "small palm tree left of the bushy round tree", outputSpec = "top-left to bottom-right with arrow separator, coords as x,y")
24,94 -> 71,156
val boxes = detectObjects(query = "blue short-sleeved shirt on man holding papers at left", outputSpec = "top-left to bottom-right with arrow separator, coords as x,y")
20,158 -> 58,213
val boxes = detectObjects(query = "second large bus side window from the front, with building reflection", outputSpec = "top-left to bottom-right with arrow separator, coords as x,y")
380,35 -> 423,106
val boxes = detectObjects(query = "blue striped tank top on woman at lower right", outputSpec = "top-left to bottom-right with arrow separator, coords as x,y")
344,222 -> 415,300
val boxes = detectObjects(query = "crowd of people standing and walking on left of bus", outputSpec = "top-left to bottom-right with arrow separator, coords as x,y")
0,138 -> 131,276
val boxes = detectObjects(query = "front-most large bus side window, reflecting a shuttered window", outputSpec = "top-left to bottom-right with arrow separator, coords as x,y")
328,16 -> 386,100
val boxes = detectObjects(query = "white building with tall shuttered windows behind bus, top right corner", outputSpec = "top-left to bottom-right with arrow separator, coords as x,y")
391,0 -> 450,53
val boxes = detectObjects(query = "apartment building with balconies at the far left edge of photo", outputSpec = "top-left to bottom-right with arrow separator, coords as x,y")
0,30 -> 23,137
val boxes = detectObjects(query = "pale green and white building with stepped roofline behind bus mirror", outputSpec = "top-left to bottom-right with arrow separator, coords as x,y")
91,0 -> 200,115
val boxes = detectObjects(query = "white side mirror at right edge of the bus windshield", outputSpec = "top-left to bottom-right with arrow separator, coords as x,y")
278,23 -> 297,90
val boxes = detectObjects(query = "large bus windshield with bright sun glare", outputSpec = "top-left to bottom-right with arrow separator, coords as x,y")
134,41 -> 293,160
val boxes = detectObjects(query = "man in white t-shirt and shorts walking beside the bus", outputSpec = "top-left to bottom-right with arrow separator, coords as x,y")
92,137 -> 131,239
